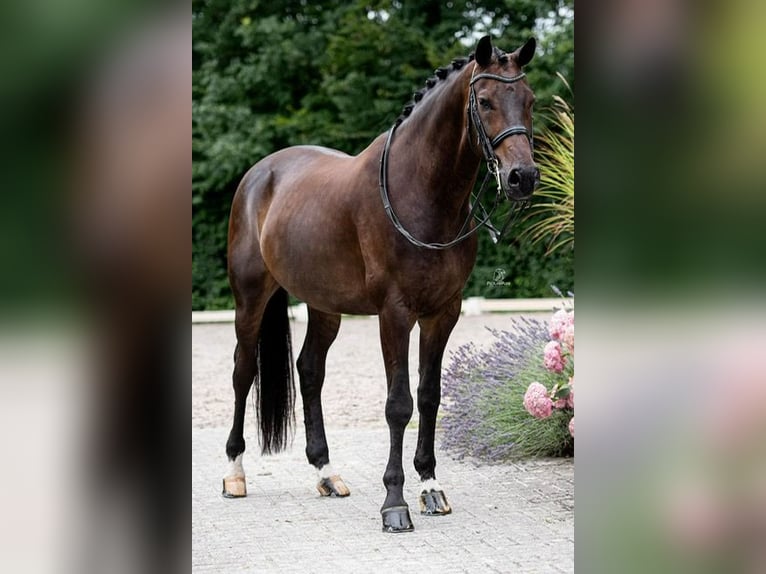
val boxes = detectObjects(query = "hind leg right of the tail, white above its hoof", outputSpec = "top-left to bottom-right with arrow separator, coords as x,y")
298,308 -> 349,496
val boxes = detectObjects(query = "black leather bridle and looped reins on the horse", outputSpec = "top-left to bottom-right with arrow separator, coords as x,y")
378,68 -> 534,250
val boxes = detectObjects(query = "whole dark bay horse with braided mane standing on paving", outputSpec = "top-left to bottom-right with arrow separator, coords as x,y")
223,36 -> 540,532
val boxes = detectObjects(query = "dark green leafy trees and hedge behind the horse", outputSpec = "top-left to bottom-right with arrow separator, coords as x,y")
192,0 -> 573,309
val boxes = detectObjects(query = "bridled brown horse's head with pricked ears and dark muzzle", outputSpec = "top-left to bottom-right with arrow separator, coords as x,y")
469,36 -> 540,200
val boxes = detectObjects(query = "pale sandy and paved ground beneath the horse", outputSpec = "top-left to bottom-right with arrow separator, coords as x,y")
192,315 -> 574,574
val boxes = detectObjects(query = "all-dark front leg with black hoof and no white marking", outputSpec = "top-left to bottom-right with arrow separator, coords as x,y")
380,309 -> 415,532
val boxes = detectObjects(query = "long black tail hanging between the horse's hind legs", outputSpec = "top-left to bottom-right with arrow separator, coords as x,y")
254,289 -> 295,454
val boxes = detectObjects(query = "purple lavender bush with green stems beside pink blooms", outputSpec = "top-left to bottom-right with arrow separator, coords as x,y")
441,317 -> 574,461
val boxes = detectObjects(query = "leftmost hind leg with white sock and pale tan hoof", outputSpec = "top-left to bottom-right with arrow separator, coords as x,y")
223,281 -> 273,498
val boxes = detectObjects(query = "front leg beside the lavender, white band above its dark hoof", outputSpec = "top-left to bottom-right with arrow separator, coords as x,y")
415,297 -> 461,516
